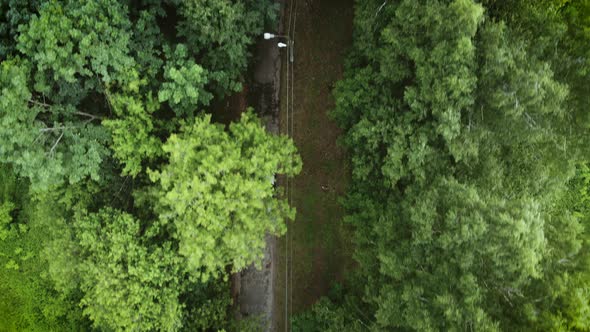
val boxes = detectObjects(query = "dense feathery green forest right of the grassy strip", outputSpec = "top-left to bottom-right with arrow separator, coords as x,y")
293,0 -> 590,331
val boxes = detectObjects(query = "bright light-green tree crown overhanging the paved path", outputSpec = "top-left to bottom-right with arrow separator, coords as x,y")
151,113 -> 301,281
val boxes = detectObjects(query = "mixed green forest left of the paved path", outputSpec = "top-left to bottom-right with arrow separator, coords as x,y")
0,0 -> 301,331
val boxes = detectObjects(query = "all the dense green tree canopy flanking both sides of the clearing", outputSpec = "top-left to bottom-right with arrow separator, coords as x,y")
0,0 -> 590,332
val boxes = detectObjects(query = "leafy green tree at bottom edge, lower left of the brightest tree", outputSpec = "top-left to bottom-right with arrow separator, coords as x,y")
76,209 -> 182,331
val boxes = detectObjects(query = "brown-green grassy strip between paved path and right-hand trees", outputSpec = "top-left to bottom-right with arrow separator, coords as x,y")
273,0 -> 354,331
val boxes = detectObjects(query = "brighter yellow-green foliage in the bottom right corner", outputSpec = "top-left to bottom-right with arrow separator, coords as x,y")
512,164 -> 590,331
